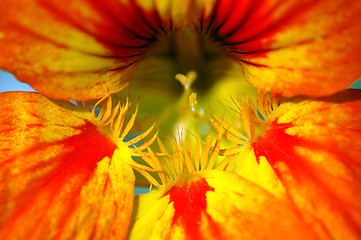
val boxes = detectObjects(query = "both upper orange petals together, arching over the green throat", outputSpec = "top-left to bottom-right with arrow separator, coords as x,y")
0,0 -> 361,100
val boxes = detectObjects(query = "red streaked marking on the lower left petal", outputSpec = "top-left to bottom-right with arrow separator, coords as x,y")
0,121 -> 116,228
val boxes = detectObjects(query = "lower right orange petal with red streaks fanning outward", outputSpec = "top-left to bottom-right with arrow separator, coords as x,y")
253,90 -> 361,239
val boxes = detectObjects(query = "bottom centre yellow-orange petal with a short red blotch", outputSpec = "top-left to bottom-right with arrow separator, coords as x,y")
130,171 -> 317,239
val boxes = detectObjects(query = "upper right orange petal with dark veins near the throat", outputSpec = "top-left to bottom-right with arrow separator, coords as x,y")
203,0 -> 361,96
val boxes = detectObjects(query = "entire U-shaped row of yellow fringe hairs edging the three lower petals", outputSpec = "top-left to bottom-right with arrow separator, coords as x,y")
78,90 -> 279,191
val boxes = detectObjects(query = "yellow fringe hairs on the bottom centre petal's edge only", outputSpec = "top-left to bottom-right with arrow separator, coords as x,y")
132,127 -> 233,188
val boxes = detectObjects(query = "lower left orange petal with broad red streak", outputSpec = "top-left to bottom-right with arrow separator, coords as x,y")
0,92 -> 134,239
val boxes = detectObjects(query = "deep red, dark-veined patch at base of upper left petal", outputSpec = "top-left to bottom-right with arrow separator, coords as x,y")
38,0 -> 166,54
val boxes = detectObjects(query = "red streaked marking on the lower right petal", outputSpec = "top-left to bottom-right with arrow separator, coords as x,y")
253,116 -> 360,238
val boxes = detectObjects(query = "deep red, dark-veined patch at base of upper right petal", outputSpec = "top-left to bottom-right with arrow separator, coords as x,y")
206,0 -> 278,57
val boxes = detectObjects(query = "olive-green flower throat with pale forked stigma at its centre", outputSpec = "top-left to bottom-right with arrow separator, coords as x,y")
116,28 -> 253,134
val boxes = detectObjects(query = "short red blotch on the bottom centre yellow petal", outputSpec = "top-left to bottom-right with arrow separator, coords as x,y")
167,178 -> 214,240
